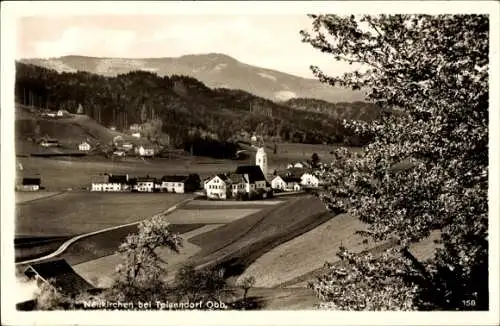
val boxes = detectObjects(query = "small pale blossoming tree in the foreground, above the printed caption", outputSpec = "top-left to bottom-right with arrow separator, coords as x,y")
109,215 -> 182,300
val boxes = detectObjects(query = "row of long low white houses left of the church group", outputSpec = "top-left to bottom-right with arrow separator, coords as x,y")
90,174 -> 201,193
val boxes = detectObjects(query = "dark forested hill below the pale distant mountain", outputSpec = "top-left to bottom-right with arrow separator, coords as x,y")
16,62 -> 376,146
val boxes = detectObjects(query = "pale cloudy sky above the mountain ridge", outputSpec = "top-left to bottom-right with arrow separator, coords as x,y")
16,14 -> 351,77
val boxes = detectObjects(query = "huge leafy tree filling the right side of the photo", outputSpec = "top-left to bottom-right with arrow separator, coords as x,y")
301,15 -> 489,310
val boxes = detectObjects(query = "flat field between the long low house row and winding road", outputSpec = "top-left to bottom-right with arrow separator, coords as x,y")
15,192 -> 191,237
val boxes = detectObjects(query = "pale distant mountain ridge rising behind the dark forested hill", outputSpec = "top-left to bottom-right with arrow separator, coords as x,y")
17,52 -> 363,103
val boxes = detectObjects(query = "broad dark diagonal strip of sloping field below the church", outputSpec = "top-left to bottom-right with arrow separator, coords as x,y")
190,196 -> 332,276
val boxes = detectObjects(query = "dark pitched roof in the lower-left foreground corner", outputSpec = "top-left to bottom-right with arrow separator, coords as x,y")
24,259 -> 94,294
